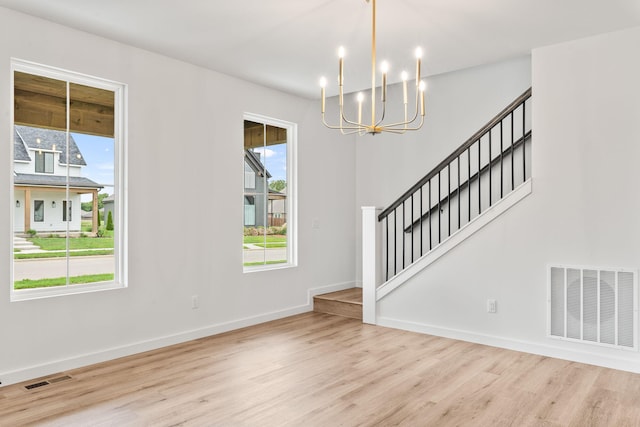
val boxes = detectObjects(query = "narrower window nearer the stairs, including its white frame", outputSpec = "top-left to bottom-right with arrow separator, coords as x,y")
242,115 -> 296,272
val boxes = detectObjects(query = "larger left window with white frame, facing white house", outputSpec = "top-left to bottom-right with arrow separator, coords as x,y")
10,60 -> 126,301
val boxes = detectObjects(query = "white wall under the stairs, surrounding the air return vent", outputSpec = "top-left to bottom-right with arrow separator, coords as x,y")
379,28 -> 640,371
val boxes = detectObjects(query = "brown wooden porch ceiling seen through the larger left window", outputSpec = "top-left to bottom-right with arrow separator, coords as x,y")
14,71 -> 115,138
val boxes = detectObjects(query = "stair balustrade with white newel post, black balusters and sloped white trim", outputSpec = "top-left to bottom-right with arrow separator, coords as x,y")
362,88 -> 532,324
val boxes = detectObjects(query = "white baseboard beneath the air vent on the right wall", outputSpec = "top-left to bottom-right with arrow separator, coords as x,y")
376,317 -> 640,373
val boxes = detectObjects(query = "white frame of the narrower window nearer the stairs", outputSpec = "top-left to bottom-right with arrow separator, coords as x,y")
240,113 -> 298,273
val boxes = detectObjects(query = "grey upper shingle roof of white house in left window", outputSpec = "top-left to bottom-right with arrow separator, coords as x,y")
13,125 -> 87,166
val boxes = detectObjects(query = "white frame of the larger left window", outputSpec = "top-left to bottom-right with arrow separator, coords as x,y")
7,58 -> 128,302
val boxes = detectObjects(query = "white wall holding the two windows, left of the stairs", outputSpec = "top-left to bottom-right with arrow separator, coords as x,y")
0,9 -> 355,385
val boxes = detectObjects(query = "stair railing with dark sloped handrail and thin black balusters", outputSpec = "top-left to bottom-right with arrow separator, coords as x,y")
378,88 -> 531,281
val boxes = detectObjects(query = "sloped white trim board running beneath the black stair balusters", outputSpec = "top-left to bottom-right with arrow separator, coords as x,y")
376,178 -> 532,301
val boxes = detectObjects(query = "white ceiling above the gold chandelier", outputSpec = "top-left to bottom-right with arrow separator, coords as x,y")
0,0 -> 640,98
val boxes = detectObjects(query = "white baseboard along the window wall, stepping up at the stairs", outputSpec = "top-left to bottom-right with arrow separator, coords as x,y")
0,282 -> 355,387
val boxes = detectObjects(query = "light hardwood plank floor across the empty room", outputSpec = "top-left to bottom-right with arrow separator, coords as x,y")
0,313 -> 640,427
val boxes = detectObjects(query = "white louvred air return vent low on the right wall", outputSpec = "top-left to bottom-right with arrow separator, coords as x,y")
547,265 -> 638,350
